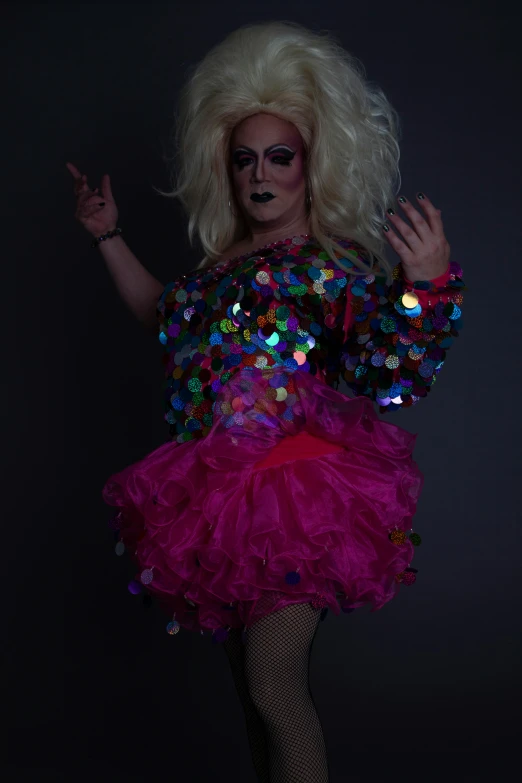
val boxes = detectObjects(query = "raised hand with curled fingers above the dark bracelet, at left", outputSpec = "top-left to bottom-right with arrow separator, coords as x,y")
66,163 -> 118,237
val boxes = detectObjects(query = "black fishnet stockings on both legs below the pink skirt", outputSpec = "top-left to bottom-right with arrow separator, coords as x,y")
224,604 -> 328,783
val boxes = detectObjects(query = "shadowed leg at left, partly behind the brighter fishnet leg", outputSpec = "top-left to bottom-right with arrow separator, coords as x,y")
220,628 -> 270,783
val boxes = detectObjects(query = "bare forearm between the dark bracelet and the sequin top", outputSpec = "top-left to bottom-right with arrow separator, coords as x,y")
98,236 -> 164,329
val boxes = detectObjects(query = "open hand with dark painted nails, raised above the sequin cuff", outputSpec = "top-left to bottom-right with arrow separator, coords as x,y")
383,194 -> 450,282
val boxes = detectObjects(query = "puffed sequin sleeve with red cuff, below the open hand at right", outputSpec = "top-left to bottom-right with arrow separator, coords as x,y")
340,262 -> 466,413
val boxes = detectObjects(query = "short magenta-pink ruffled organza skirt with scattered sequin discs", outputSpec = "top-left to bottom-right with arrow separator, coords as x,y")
103,367 -> 424,641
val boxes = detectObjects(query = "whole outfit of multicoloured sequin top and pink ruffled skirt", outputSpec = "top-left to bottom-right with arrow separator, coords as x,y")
104,236 -> 465,642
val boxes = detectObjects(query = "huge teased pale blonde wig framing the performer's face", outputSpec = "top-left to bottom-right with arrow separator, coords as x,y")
155,21 -> 400,283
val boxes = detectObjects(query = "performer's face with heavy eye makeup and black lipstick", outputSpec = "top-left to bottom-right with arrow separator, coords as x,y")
230,114 -> 306,229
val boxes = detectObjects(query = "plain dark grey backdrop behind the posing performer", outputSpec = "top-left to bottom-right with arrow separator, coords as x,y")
0,0 -> 521,783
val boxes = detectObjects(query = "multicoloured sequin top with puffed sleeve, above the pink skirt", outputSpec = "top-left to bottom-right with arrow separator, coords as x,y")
157,236 -> 465,443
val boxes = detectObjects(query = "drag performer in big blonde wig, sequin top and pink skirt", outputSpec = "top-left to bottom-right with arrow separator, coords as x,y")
68,22 -> 464,783
